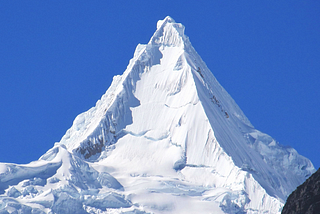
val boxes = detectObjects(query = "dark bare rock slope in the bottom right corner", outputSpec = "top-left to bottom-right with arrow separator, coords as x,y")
282,169 -> 320,214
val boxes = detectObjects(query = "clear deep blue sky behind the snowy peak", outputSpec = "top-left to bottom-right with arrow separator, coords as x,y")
0,0 -> 320,168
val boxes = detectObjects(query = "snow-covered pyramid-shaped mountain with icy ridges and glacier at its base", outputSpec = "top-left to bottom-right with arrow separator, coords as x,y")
0,17 -> 315,213
